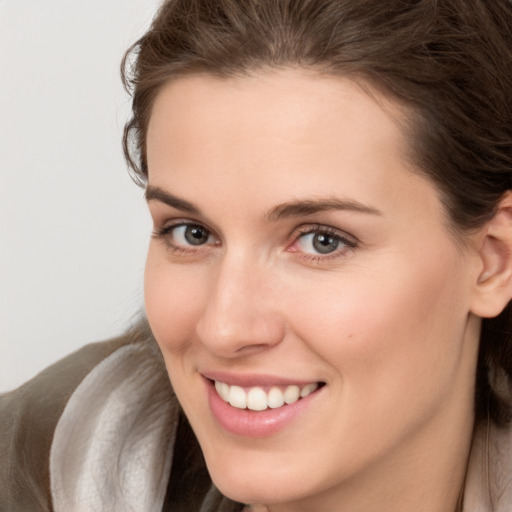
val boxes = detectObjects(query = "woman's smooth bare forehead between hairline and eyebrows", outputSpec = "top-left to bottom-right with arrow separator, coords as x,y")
147,69 -> 437,228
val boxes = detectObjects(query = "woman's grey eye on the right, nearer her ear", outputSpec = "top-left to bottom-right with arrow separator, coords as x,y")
289,226 -> 357,258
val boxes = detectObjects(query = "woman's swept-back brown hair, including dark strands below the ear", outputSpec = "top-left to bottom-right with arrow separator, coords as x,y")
122,0 -> 512,424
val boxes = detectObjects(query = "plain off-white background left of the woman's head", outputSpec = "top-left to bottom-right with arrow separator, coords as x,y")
0,0 -> 159,391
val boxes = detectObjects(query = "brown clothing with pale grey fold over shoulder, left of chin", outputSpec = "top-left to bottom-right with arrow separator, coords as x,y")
0,324 -> 243,512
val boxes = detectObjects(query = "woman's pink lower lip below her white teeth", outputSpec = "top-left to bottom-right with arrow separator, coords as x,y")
206,380 -> 323,437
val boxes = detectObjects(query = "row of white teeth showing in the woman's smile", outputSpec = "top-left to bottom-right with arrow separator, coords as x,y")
215,381 -> 318,411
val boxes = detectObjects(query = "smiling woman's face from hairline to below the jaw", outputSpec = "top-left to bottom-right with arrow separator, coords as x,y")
145,70 -> 479,510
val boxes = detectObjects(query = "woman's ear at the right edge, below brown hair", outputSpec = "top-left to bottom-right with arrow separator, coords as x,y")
471,191 -> 512,318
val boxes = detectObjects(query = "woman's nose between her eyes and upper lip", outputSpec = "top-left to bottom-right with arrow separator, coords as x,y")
196,256 -> 284,358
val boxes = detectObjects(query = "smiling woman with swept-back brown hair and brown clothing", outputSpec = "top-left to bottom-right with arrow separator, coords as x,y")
0,0 -> 512,512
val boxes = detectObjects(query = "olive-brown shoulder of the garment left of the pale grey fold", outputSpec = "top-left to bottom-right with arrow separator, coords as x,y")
0,324 -> 156,512
